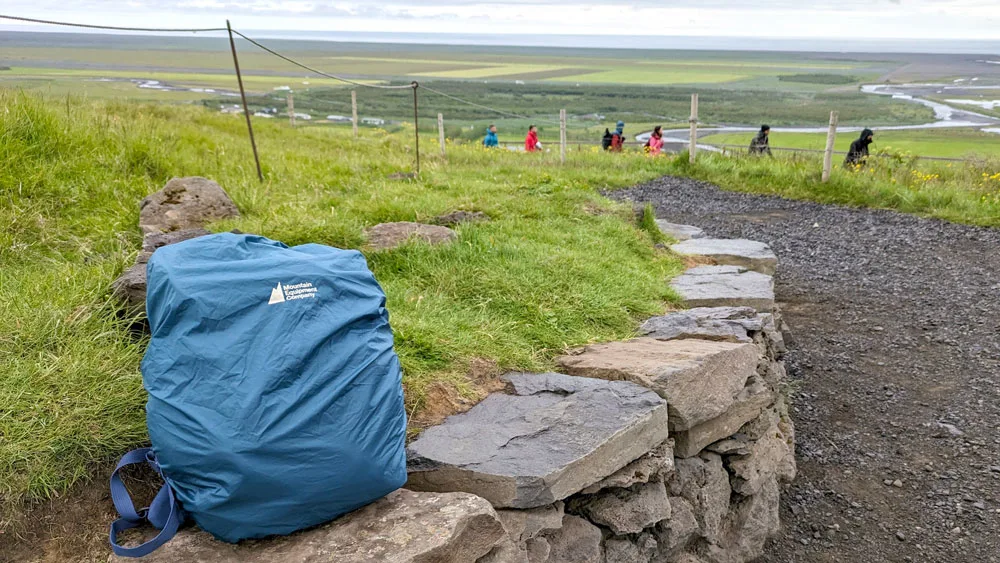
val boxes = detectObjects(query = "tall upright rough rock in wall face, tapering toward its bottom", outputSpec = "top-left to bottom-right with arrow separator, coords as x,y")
667,453 -> 732,543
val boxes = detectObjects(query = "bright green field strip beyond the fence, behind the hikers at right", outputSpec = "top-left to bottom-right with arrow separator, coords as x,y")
704,129 -> 1000,158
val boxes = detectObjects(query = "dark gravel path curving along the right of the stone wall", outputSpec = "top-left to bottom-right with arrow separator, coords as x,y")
611,177 -> 1000,563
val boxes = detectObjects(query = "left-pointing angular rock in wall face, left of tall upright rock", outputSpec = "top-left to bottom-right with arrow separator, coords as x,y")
570,482 -> 670,535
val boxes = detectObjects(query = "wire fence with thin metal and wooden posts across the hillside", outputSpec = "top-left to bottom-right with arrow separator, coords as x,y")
0,14 -> 992,181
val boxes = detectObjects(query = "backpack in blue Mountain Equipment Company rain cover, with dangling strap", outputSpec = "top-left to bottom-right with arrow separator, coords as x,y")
110,233 -> 406,557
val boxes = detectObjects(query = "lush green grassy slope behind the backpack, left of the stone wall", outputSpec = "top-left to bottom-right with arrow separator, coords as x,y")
0,90 -> 680,529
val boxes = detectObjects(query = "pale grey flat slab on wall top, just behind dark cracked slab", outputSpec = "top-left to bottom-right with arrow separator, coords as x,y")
670,266 -> 774,312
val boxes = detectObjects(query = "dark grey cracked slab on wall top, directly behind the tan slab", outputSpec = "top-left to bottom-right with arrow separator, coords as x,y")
639,307 -> 774,342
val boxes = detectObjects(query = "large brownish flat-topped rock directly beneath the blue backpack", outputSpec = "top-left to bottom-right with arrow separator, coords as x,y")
109,490 -> 507,563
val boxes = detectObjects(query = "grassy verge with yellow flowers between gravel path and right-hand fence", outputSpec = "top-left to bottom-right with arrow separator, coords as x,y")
652,153 -> 1000,227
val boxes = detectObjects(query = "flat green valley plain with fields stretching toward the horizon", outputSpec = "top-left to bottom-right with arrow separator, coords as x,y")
0,32 -> 1000,156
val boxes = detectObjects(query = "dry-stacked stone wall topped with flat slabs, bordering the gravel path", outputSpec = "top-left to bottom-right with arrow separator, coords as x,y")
111,229 -> 795,563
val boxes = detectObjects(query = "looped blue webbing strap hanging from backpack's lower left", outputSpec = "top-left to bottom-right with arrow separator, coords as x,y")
110,448 -> 184,557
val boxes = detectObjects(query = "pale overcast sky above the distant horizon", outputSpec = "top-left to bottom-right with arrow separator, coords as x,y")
0,0 -> 1000,39
